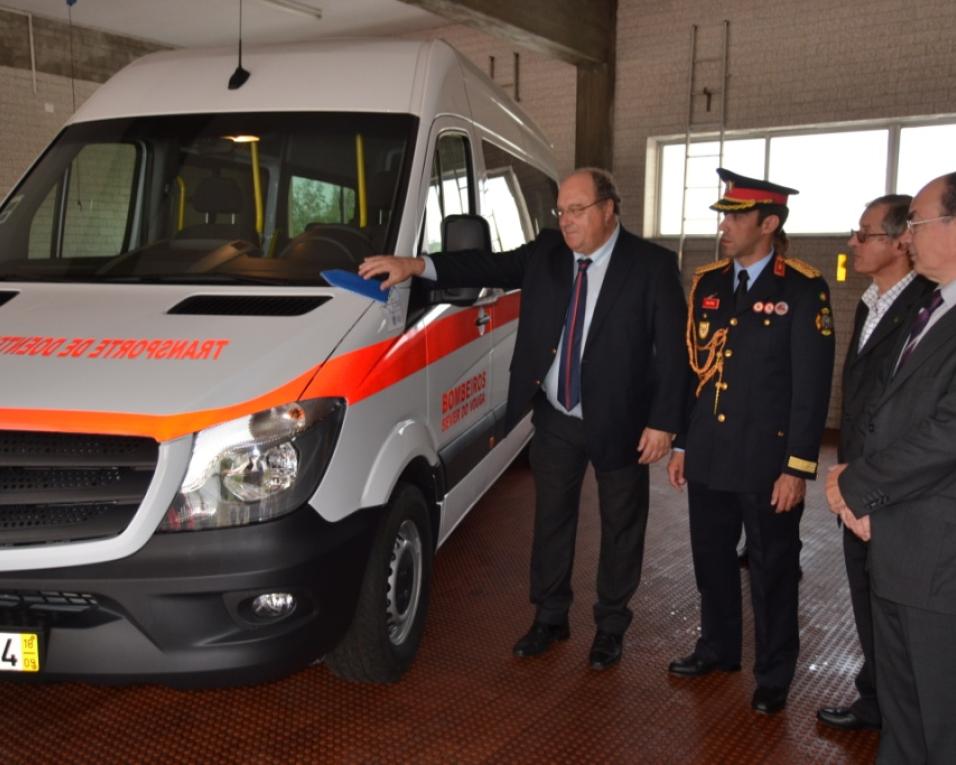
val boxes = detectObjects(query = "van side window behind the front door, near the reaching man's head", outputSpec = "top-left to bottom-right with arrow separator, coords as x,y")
481,141 -> 558,240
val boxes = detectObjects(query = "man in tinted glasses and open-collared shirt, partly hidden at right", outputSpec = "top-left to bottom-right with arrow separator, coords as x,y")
817,194 -> 932,730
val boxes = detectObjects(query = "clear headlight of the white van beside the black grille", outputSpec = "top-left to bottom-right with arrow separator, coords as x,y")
158,398 -> 345,531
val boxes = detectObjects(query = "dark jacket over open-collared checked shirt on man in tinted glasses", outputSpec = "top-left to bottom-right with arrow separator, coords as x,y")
837,276 -> 933,462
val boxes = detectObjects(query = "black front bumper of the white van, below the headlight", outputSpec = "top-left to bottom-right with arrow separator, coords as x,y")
0,506 -> 378,687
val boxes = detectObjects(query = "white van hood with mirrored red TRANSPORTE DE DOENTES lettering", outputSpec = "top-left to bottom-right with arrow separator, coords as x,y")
0,283 -> 372,430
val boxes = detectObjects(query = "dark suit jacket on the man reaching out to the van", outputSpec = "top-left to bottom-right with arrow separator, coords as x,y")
434,228 -> 687,470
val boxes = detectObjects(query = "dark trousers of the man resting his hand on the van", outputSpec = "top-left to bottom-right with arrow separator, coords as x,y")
531,396 -> 649,635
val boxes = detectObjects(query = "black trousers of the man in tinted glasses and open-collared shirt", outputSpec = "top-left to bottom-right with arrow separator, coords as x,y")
843,528 -> 880,725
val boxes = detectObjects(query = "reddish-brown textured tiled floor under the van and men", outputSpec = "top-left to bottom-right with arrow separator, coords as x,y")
0,438 -> 878,765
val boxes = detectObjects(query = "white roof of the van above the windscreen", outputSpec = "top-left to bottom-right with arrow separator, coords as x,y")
69,39 -> 553,173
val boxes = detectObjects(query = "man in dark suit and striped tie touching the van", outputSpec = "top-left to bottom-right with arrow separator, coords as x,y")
359,169 -> 687,669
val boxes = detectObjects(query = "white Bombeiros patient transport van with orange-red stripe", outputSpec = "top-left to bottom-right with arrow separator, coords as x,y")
0,41 -> 556,685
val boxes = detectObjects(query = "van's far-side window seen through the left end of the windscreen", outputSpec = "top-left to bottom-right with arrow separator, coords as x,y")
27,143 -> 137,259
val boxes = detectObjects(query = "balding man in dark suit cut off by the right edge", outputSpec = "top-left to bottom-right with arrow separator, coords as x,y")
827,173 -> 956,764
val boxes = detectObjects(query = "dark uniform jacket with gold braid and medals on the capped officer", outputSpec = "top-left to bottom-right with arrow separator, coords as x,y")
681,256 -> 834,492
